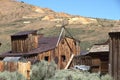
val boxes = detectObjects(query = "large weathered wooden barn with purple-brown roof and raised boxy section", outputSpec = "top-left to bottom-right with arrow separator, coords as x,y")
0,30 -> 80,69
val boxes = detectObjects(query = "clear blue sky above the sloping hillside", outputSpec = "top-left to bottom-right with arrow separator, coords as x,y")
19,0 -> 120,20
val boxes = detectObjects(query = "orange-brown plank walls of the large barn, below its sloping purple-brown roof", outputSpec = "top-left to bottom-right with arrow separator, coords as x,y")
38,38 -> 80,69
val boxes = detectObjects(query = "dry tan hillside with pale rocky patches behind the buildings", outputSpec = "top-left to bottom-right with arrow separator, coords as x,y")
0,0 -> 120,52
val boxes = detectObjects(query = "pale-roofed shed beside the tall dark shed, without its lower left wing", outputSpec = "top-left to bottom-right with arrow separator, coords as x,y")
87,43 -> 109,74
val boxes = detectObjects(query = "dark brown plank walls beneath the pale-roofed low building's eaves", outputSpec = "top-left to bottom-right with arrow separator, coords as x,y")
72,55 -> 108,74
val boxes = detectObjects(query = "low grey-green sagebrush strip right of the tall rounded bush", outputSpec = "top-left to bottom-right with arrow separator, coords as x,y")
48,69 -> 112,80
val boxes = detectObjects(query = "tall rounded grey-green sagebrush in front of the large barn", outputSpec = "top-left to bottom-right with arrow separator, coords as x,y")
31,61 -> 56,80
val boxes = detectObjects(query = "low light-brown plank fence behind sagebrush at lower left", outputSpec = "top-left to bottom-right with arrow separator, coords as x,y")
0,61 -> 31,80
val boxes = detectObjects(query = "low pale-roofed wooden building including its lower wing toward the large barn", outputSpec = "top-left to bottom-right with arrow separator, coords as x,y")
73,41 -> 109,74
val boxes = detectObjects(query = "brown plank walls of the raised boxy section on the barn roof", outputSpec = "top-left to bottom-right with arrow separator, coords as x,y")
11,34 -> 38,53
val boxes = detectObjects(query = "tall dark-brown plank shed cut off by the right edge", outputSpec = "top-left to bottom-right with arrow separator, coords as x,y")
109,27 -> 120,80
